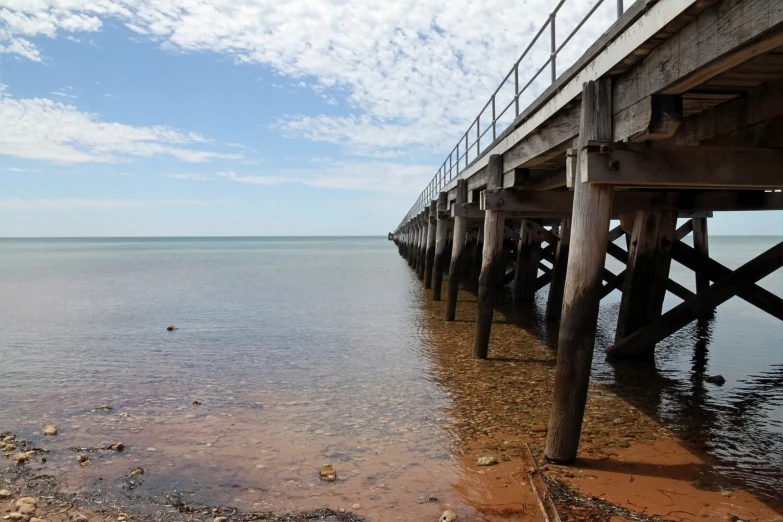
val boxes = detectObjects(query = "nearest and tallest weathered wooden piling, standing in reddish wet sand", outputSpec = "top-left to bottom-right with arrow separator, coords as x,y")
544,79 -> 613,463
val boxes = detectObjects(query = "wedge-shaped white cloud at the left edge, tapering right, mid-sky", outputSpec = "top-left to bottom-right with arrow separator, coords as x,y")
0,84 -> 242,163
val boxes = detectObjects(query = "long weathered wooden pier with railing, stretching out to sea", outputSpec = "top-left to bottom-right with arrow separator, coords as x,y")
389,0 -> 783,463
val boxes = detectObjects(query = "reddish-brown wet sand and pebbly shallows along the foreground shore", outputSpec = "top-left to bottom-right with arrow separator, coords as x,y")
0,276 -> 783,522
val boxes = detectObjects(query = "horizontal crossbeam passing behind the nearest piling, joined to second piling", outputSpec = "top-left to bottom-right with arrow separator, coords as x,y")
481,188 -> 783,212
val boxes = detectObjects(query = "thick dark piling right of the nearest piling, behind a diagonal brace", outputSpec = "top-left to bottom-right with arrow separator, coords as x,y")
615,212 -> 677,343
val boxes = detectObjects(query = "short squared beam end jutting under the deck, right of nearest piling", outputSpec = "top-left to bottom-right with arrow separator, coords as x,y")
614,94 -> 682,141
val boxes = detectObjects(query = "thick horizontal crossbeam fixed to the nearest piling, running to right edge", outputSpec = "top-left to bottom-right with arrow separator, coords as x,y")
583,143 -> 783,190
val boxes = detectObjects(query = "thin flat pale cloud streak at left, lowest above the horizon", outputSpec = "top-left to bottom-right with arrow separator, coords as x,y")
0,198 -> 217,210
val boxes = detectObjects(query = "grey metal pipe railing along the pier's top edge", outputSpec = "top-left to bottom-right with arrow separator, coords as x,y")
398,0 -> 623,228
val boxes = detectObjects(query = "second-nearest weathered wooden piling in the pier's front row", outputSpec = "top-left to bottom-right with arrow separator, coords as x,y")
473,154 -> 506,359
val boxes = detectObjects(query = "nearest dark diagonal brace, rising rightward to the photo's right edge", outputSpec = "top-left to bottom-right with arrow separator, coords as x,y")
607,242 -> 783,357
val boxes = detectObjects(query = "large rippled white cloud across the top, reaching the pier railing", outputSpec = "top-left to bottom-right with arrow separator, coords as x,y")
0,0 -> 614,156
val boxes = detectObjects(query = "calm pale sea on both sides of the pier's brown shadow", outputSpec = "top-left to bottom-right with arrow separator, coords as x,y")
0,237 -> 783,520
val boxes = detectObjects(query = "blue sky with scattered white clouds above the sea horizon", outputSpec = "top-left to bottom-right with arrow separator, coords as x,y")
0,0 -> 783,237
